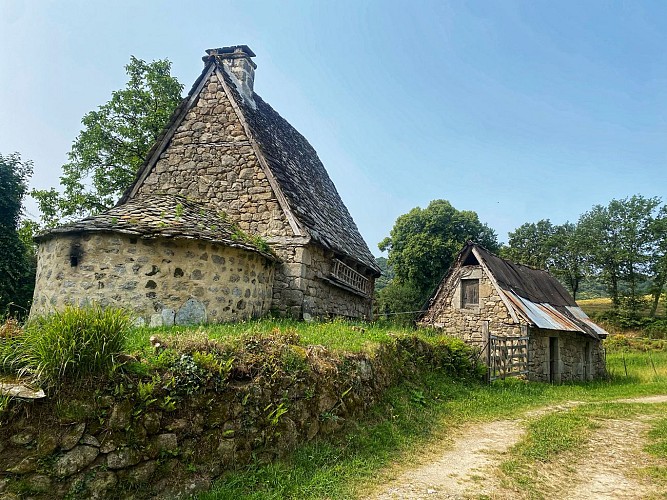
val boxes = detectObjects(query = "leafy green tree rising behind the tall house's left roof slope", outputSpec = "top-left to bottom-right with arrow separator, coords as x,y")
31,56 -> 183,226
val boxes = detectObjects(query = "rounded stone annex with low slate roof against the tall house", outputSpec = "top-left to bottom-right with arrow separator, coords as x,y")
32,195 -> 277,326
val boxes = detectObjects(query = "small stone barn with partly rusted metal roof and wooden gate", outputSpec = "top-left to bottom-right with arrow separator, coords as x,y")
420,242 -> 607,382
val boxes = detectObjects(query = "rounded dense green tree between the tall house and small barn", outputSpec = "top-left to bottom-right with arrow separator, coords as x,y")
378,200 -> 499,303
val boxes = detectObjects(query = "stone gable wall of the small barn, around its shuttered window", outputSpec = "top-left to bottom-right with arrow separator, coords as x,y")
421,266 -> 521,347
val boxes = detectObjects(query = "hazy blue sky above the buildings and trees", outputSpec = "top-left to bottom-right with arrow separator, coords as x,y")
0,0 -> 667,255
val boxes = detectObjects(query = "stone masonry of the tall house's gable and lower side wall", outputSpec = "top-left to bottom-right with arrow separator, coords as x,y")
130,70 -> 371,318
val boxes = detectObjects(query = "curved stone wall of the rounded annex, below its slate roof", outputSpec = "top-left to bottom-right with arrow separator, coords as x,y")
31,233 -> 274,326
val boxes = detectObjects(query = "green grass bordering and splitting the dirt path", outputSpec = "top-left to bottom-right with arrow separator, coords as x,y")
200,338 -> 667,500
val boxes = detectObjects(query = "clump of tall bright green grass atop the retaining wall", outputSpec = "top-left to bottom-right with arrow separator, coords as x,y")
14,306 -> 132,386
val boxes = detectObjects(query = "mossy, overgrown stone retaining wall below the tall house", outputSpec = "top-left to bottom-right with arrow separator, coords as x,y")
0,337 -> 470,499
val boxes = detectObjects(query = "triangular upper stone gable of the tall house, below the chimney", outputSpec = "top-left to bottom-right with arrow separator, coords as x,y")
139,74 -> 292,238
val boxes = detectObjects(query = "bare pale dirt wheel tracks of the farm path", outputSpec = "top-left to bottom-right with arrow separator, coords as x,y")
368,396 -> 667,500
